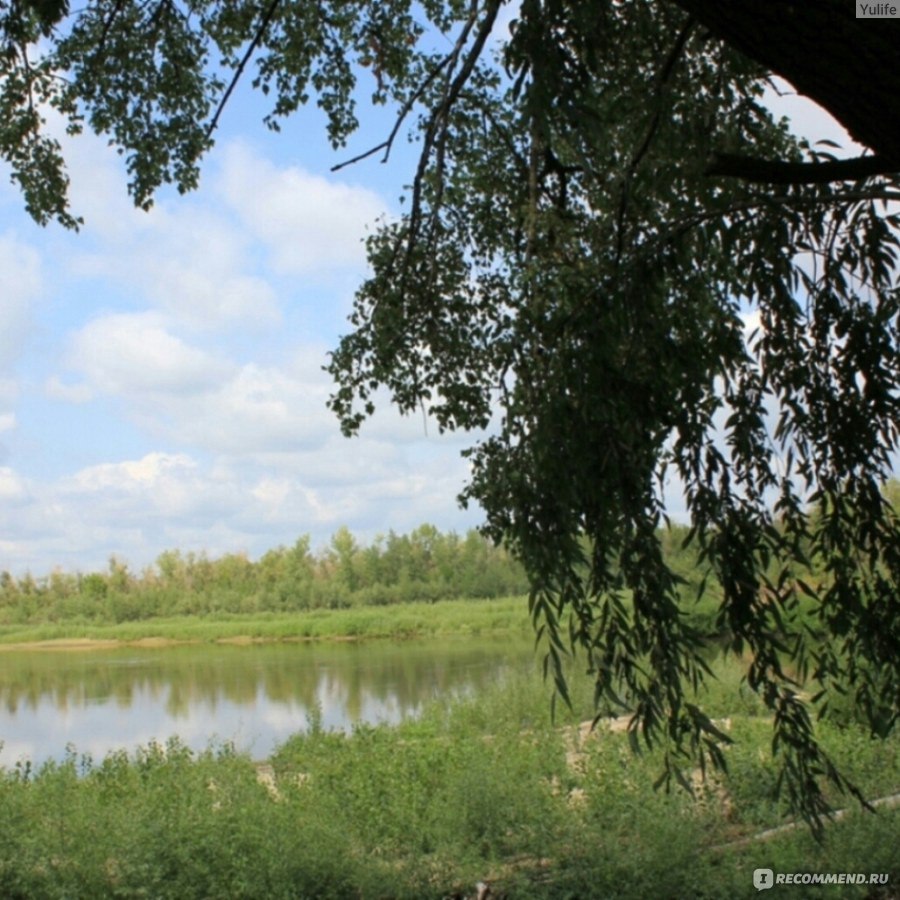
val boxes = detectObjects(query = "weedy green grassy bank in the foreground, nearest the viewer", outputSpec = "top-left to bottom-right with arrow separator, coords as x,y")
0,673 -> 900,900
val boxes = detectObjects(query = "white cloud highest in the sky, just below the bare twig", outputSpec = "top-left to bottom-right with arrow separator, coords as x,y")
219,144 -> 387,275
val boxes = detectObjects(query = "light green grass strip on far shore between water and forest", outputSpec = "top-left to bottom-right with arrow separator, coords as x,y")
0,597 -> 531,647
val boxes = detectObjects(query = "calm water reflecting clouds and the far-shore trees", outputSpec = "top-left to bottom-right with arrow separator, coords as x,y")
0,637 -> 536,766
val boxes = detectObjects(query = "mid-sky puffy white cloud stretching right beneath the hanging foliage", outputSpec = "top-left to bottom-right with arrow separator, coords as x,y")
64,313 -> 478,460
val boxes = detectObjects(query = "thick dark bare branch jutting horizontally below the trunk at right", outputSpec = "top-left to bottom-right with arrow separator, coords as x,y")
705,153 -> 900,185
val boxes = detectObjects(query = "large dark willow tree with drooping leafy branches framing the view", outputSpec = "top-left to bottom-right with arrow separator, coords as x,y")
0,0 -> 900,822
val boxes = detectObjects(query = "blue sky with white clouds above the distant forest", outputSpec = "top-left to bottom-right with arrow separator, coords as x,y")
0,45 -> 847,577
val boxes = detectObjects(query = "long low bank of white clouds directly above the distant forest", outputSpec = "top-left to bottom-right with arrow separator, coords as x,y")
0,432 -> 478,574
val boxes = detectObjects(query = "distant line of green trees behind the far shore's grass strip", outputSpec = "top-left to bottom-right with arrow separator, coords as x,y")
0,525 -> 528,625
